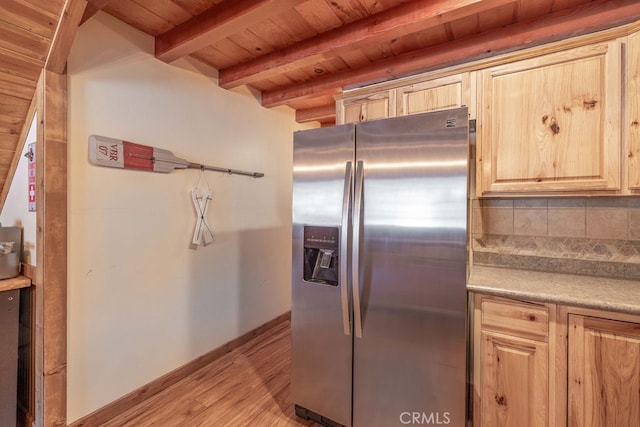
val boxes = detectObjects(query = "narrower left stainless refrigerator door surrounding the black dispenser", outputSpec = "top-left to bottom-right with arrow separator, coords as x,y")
291,125 -> 355,426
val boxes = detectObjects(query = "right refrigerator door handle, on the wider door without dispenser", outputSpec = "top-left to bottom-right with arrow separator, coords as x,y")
351,160 -> 364,338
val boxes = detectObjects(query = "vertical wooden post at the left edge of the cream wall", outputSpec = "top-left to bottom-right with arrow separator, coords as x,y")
34,70 -> 67,427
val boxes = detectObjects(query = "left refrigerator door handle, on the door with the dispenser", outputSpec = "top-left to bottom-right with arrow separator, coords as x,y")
340,162 -> 353,335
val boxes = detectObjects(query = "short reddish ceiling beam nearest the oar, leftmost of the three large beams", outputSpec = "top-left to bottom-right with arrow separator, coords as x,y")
156,0 -> 306,62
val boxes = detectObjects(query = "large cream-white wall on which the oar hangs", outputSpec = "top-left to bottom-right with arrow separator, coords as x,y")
68,14 -> 316,422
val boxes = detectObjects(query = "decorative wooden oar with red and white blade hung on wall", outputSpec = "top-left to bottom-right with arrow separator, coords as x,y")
89,135 -> 264,178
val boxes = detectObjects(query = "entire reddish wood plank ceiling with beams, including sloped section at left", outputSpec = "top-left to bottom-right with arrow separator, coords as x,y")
0,0 -> 640,209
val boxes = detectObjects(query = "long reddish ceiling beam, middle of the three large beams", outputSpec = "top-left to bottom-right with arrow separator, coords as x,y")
218,0 -> 515,89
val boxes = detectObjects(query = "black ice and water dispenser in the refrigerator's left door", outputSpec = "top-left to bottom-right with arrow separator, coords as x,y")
303,226 -> 340,286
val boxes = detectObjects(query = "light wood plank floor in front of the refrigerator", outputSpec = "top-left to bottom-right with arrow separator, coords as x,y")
103,321 -> 316,427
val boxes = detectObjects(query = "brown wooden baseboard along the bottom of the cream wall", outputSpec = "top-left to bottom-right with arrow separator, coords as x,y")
69,311 -> 291,427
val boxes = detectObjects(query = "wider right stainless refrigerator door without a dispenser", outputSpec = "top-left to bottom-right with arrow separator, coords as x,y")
353,108 -> 468,427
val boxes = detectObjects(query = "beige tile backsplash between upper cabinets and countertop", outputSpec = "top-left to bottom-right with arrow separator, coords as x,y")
471,197 -> 640,265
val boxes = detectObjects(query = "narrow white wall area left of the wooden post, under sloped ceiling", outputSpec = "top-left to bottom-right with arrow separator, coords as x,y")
0,117 -> 37,266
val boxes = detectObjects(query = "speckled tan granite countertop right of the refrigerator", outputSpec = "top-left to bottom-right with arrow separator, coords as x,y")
467,265 -> 640,315
